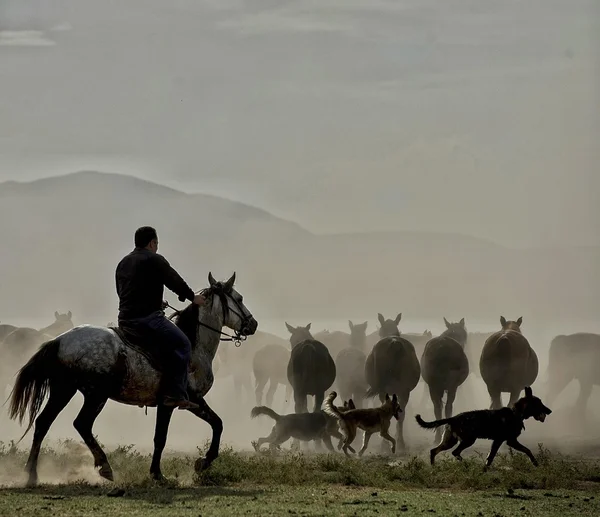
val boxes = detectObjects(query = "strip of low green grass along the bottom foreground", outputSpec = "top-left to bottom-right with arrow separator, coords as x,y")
0,441 -> 600,517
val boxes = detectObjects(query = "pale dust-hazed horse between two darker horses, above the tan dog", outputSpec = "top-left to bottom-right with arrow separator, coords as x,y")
335,321 -> 368,409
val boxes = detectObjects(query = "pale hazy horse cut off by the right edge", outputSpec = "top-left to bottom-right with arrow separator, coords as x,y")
547,332 -> 600,417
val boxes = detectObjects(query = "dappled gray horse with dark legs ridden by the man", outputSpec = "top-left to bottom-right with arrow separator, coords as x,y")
9,273 -> 258,486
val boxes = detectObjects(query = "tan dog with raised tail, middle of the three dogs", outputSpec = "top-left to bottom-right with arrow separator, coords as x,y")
323,391 -> 402,456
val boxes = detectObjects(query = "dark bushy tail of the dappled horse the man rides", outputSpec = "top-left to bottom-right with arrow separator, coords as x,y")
8,339 -> 60,442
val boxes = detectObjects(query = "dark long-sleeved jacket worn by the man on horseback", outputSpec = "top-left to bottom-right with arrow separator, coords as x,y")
115,248 -> 194,321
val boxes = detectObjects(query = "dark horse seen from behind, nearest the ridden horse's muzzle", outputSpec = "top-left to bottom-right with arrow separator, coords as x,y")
285,322 -> 336,413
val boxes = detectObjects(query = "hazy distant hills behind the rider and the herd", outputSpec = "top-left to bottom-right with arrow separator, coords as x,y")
0,171 -> 600,321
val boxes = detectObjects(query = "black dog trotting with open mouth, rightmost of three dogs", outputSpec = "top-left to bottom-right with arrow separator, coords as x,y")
415,387 -> 552,467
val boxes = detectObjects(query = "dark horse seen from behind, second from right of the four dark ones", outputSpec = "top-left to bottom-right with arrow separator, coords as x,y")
421,318 -> 469,442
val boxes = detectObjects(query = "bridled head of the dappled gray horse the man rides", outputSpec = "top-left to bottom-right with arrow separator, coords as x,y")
203,273 -> 258,336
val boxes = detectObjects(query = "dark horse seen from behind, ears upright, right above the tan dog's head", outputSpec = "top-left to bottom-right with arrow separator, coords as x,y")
365,313 -> 421,450
